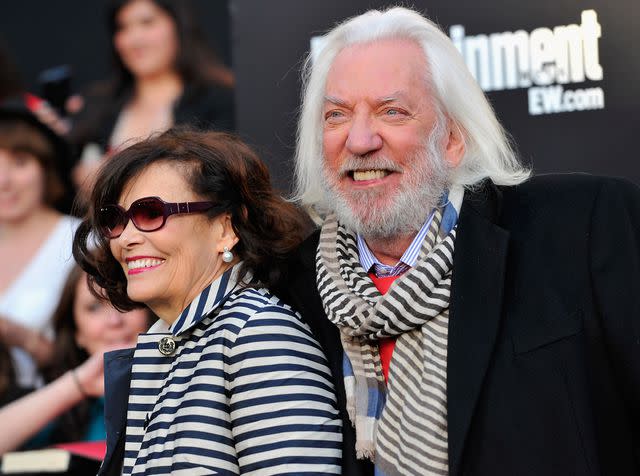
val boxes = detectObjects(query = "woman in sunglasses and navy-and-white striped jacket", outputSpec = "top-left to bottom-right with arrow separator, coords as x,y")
74,129 -> 342,474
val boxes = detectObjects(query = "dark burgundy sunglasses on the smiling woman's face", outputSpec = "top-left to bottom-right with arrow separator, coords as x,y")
98,197 -> 214,239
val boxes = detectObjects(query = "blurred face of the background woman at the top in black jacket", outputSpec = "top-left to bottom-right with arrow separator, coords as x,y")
113,0 -> 178,77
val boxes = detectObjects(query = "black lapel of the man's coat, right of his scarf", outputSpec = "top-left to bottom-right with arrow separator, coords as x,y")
447,185 -> 509,476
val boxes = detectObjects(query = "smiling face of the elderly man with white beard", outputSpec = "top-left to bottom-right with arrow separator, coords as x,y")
323,39 -> 459,238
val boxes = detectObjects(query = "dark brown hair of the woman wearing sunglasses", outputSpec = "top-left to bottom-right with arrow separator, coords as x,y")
73,127 -> 311,311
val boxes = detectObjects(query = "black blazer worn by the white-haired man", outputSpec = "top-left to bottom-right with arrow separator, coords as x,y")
277,174 -> 640,476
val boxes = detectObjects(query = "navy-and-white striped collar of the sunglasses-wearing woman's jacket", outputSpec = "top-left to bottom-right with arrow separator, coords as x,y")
169,264 -> 240,336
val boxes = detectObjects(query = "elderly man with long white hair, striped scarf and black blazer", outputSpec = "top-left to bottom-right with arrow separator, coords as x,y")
280,8 -> 640,476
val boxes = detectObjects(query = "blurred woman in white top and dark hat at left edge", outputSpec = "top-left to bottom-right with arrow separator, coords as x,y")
0,95 -> 79,388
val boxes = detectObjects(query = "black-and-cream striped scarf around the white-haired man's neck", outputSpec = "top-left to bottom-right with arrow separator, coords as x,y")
316,190 -> 462,475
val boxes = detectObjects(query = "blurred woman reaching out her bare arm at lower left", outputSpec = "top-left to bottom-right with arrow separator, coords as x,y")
0,267 -> 150,455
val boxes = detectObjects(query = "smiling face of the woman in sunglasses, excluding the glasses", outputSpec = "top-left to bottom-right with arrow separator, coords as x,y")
111,161 -> 237,324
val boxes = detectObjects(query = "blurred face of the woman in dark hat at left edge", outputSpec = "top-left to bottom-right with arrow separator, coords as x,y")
0,148 -> 45,222
